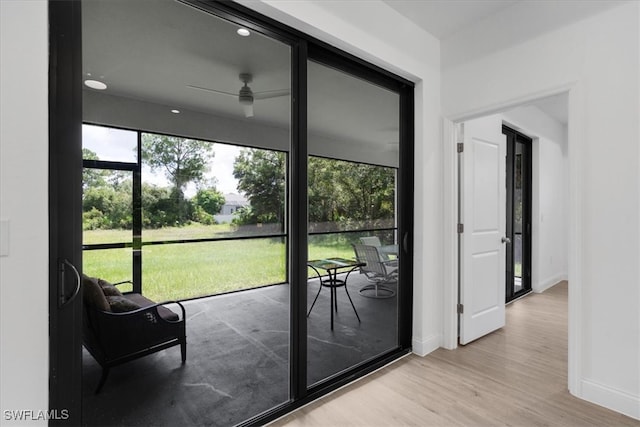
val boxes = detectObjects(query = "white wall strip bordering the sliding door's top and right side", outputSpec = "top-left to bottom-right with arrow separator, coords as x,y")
238,0 -> 443,355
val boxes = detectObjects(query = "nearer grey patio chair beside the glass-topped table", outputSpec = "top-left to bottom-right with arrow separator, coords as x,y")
352,245 -> 398,298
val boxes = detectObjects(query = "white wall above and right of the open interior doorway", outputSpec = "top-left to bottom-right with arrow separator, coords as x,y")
442,2 -> 640,418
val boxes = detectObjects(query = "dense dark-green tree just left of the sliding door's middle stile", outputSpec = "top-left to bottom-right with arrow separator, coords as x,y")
233,148 -> 285,224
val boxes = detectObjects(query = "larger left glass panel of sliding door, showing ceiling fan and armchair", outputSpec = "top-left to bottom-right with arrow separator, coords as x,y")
82,0 -> 292,425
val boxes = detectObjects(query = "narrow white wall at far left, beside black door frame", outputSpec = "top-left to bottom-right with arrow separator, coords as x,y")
0,1 -> 49,425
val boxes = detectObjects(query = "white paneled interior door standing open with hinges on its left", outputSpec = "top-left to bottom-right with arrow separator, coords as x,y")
459,116 -> 507,344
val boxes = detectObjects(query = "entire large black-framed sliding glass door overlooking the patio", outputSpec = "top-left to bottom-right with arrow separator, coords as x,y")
52,0 -> 413,425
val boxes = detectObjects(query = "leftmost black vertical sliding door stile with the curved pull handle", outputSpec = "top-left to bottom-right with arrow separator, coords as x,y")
48,1 -> 82,426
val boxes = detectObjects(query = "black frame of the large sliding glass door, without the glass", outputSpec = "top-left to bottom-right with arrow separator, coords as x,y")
49,0 -> 414,425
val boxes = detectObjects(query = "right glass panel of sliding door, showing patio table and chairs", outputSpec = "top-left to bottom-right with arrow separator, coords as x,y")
307,61 -> 400,386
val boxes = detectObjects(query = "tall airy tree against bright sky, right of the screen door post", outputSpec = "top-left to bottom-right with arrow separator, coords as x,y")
142,134 -> 214,225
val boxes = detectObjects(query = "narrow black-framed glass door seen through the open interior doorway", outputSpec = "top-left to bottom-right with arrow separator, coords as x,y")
502,125 -> 533,303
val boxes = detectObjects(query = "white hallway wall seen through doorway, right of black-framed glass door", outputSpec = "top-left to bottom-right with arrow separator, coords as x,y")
502,106 -> 569,292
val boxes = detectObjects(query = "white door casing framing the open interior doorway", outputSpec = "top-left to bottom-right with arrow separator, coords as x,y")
443,82 -> 585,398
